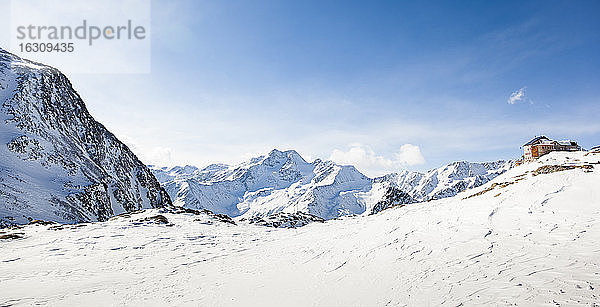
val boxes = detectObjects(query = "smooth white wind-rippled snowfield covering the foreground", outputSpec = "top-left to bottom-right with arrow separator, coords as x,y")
0,153 -> 600,306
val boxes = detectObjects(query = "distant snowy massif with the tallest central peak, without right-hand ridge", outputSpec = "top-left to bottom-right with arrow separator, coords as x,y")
151,150 -> 371,219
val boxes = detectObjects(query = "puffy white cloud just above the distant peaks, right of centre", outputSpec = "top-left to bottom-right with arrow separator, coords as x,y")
329,144 -> 425,177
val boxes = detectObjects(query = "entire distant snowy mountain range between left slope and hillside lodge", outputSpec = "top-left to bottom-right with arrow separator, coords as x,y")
150,150 -> 513,219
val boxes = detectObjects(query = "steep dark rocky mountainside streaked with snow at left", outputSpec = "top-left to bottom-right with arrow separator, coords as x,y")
0,49 -> 170,225
